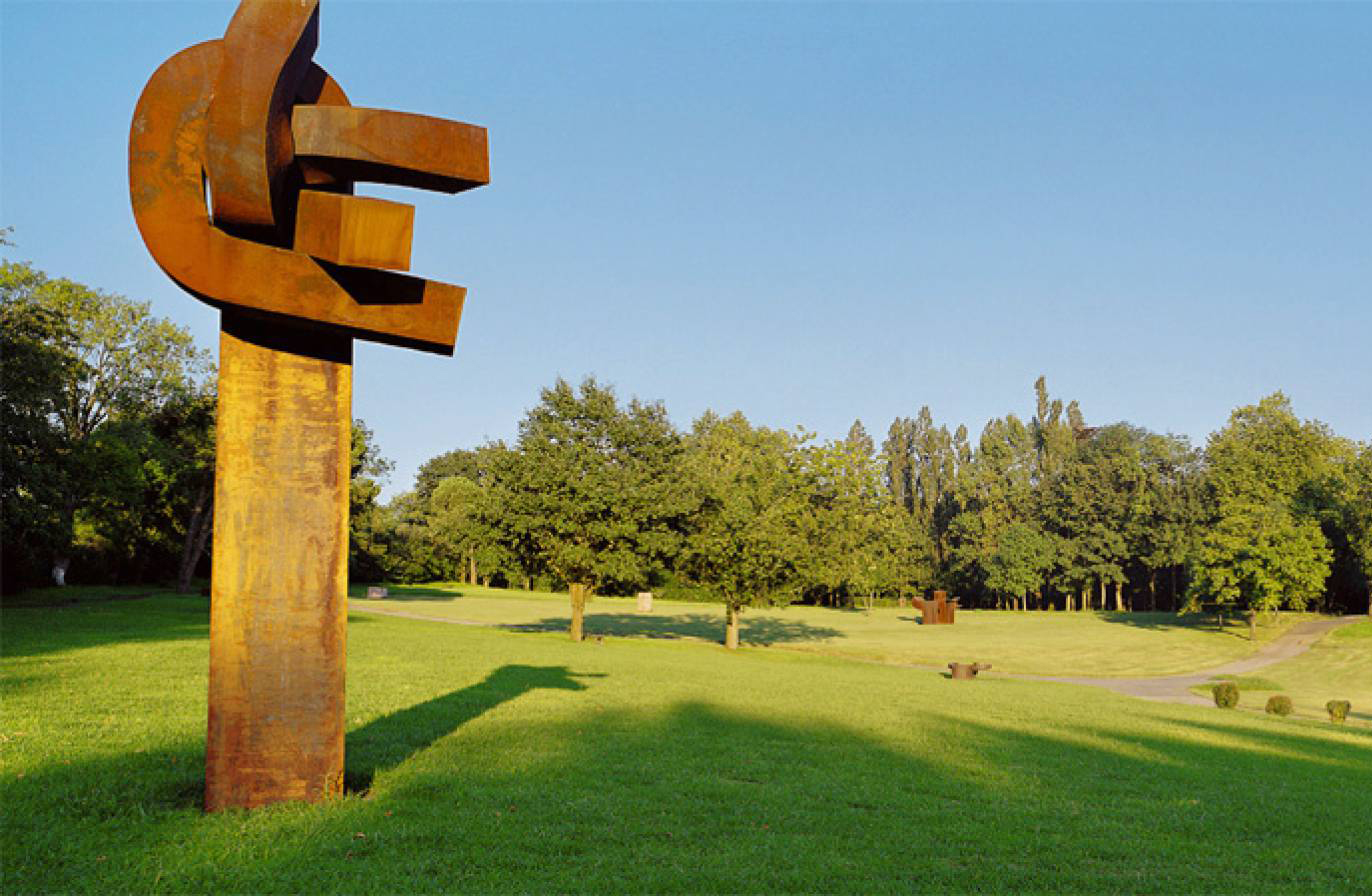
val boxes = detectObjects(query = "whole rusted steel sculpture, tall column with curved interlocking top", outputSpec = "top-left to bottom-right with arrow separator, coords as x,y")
129,0 -> 490,811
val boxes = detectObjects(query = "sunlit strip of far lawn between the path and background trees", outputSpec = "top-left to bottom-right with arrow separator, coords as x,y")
345,585 -> 1301,676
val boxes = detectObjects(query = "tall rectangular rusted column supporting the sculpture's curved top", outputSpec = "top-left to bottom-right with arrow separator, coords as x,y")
204,311 -> 353,811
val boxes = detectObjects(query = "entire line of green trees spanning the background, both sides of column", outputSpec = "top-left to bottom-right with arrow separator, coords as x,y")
8,255 -> 1372,625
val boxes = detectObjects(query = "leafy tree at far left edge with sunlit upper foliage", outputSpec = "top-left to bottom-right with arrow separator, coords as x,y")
0,262 -> 209,583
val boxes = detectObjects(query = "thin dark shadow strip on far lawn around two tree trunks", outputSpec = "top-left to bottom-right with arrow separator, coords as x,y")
501,612 -> 847,646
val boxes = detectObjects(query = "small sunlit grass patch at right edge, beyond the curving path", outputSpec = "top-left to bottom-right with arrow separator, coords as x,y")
1196,620 -> 1372,726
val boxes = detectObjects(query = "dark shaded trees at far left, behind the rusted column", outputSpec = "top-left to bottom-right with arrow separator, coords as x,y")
0,257 -> 390,594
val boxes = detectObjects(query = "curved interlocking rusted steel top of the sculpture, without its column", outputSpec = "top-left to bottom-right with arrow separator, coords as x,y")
129,0 -> 490,354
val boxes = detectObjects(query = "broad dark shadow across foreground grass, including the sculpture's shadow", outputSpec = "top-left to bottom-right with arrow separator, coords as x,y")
0,686 -> 1372,893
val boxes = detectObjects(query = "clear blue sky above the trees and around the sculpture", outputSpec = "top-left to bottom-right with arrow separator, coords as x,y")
0,0 -> 1372,493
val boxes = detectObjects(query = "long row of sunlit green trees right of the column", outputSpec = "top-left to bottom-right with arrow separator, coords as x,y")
356,377 -> 1372,625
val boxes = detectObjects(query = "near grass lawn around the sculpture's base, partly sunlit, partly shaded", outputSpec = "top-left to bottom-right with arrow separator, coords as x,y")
0,597 -> 1372,893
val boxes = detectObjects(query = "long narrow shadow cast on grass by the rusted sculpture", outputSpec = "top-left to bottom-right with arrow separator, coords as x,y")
343,665 -> 605,793
